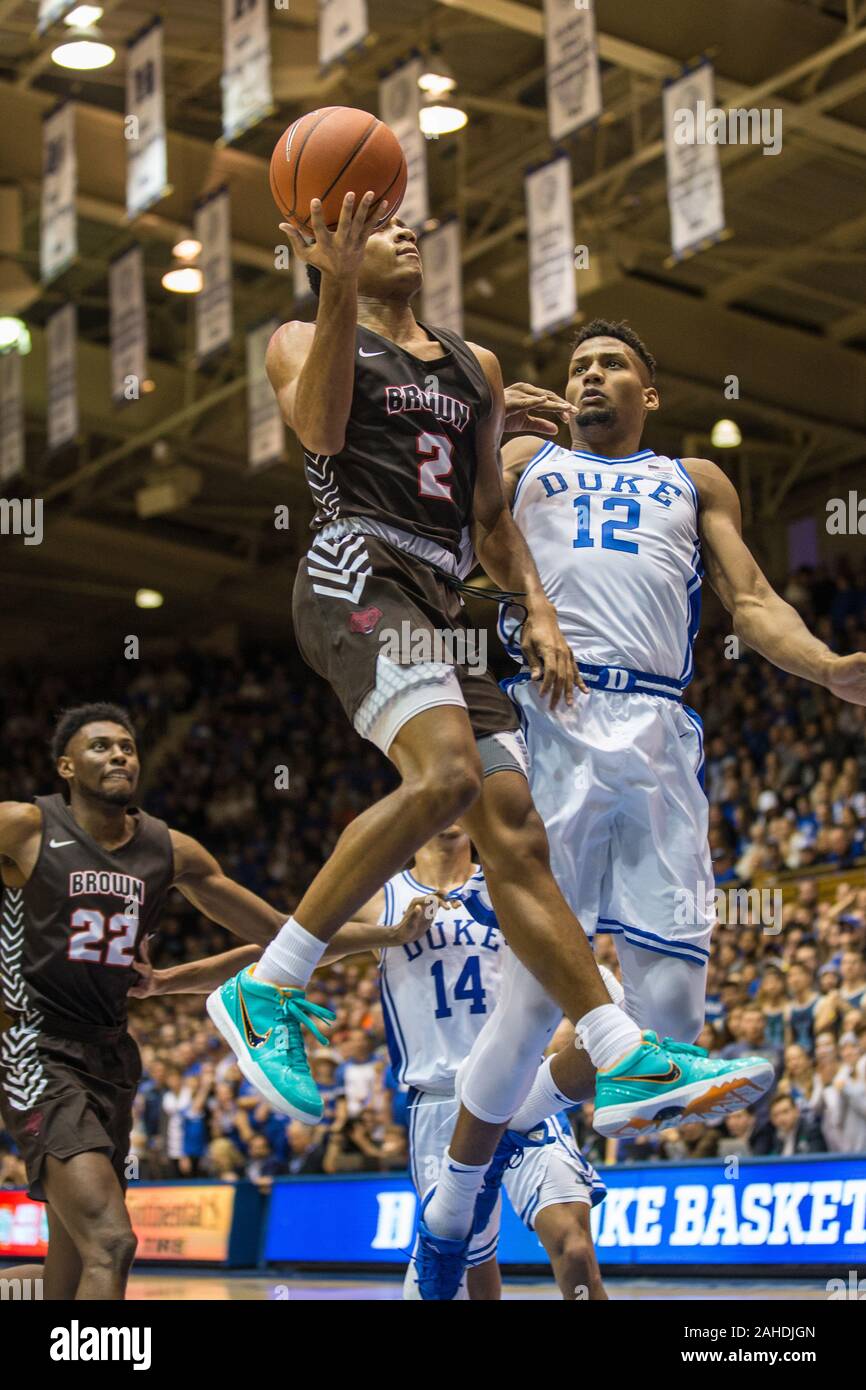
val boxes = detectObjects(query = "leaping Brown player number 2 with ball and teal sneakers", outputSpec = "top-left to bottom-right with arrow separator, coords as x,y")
209,165 -> 773,1298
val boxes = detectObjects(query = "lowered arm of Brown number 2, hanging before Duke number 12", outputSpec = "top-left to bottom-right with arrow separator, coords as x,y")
467,343 -> 585,709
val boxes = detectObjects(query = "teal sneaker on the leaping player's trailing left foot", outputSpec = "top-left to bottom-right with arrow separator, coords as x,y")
207,966 -> 335,1125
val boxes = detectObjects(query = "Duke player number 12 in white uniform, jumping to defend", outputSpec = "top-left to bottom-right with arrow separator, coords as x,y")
480,320 -> 866,1133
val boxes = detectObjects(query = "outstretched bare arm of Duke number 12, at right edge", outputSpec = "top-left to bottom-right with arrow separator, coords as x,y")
685,459 -> 866,705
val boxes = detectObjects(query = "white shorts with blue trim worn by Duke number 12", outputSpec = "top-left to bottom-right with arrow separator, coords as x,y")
505,676 -> 714,966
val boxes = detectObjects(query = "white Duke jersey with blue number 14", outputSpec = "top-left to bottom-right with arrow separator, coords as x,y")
379,869 -> 509,1094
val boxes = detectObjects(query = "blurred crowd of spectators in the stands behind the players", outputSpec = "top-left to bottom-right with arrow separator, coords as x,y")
0,553 -> 866,1186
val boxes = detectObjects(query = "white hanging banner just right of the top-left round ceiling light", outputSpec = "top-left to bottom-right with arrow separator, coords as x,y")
124,19 -> 168,218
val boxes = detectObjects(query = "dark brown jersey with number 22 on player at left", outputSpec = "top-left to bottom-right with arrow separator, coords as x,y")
0,795 -> 174,1036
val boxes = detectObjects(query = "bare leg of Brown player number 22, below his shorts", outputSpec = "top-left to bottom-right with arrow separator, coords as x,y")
42,1151 -> 138,1300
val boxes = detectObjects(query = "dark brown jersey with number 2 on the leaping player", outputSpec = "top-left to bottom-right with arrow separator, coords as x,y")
302,325 -> 491,557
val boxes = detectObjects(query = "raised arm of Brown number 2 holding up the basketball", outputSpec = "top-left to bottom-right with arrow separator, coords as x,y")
265,193 -> 375,455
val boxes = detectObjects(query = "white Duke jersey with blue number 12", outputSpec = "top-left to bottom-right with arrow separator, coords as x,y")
500,443 -> 703,687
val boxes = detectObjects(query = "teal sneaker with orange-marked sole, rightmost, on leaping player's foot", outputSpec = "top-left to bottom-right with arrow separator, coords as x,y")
592,1031 -> 774,1138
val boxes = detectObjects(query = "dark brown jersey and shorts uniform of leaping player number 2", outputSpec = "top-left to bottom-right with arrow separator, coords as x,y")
293,325 -> 517,738
